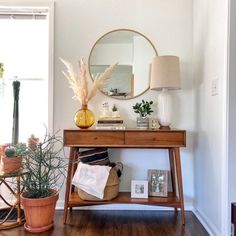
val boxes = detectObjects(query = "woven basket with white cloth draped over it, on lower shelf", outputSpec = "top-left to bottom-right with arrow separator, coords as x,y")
78,167 -> 120,201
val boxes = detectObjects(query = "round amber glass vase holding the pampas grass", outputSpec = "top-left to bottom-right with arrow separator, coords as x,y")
74,104 -> 95,129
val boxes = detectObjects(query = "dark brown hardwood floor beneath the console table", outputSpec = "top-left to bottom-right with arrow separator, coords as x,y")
0,210 -> 209,236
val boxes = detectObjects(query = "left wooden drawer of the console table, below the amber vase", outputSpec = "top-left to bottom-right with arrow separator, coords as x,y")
64,130 -> 124,147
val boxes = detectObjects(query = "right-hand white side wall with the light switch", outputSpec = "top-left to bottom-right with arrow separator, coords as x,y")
193,0 -> 228,235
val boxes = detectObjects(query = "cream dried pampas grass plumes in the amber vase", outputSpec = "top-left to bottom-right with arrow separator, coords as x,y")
60,58 -> 117,105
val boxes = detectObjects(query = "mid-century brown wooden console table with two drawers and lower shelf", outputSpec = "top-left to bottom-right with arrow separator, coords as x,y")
63,129 -> 186,225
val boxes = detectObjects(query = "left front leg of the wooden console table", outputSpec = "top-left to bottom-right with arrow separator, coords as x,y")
63,147 -> 76,224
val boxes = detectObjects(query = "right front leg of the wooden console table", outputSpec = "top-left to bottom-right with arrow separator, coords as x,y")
174,148 -> 185,225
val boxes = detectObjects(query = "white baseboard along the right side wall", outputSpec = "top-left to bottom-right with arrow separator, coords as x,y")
193,208 -> 221,236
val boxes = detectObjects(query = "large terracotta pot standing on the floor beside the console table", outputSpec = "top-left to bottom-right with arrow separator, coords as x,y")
21,191 -> 59,233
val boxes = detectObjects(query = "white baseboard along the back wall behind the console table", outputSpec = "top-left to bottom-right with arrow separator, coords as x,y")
56,200 -> 193,211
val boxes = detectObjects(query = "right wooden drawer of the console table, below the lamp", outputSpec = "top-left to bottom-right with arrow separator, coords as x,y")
125,131 -> 186,147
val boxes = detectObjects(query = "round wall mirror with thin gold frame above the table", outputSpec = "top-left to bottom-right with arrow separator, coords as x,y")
88,29 -> 157,99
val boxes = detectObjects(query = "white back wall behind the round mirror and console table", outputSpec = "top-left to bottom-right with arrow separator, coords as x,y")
54,0 -> 194,208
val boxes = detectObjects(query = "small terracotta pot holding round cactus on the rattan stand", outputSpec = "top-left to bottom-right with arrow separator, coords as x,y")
1,156 -> 22,173
